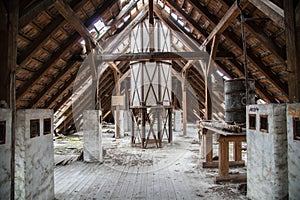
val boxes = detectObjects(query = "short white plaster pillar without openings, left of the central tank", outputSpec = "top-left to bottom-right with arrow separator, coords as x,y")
83,110 -> 103,162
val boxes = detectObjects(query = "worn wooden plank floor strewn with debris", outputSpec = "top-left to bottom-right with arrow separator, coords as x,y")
54,126 -> 246,200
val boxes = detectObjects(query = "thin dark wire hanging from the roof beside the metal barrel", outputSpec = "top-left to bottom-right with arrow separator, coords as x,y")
237,0 -> 251,105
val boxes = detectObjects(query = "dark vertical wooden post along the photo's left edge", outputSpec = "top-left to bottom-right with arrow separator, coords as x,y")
0,0 -> 19,199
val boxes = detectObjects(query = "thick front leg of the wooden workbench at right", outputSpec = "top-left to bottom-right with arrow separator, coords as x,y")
219,135 -> 229,177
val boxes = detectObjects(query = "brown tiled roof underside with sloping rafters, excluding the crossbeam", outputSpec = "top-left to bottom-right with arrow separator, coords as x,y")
16,0 -> 288,134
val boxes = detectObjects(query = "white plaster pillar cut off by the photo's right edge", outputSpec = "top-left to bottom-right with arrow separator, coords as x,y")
287,103 -> 300,200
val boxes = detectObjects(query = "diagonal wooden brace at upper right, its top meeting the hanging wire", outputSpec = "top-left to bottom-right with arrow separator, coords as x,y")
201,1 -> 248,48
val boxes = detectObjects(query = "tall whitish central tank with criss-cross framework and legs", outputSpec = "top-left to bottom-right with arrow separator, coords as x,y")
130,19 -> 172,148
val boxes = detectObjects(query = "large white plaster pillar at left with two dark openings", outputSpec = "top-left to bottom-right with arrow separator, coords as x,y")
15,109 -> 54,200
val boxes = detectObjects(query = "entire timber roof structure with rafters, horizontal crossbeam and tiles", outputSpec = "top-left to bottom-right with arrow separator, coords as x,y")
0,0 -> 300,133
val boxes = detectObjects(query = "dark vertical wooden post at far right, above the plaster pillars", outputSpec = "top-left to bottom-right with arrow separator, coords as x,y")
283,1 -> 300,102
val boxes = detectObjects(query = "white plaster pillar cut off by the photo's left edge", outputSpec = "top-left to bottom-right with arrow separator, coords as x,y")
0,109 -> 11,199
